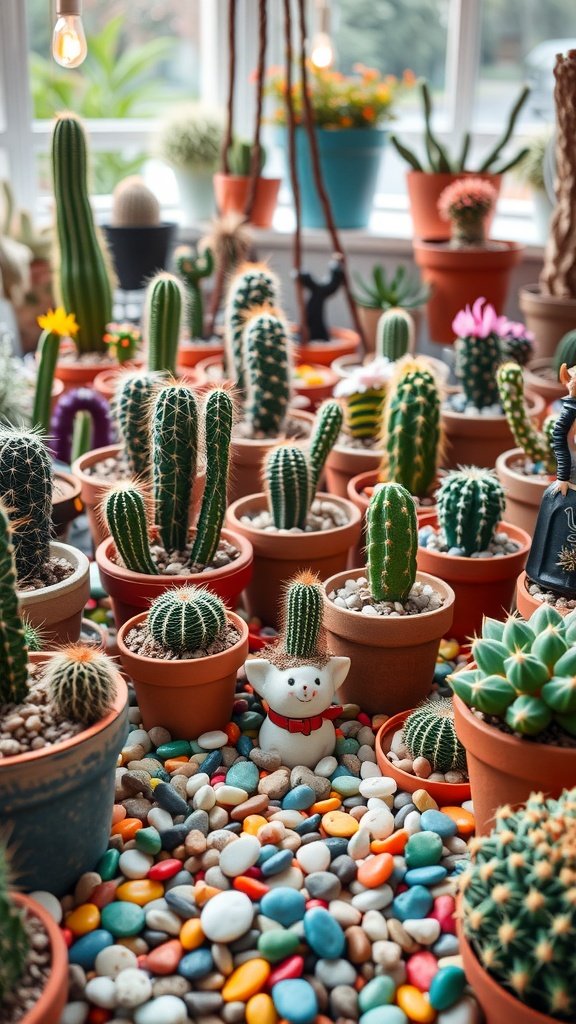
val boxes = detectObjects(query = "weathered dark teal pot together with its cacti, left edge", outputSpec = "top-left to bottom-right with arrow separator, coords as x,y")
0,510 -> 128,896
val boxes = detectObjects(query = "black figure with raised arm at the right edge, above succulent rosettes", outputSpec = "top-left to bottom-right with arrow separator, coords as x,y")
526,364 -> 576,598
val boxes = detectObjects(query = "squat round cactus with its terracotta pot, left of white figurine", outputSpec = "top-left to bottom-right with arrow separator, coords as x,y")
118,586 -> 248,739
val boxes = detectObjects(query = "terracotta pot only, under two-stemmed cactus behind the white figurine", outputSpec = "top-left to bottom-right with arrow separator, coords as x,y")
225,493 -> 361,628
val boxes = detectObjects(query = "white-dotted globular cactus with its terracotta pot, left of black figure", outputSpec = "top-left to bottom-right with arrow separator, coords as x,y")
418,467 -> 530,641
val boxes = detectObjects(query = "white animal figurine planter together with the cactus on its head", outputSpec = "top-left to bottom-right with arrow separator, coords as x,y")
245,572 -> 351,768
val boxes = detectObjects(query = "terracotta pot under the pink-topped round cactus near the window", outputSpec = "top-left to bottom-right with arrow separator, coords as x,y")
412,239 -> 524,345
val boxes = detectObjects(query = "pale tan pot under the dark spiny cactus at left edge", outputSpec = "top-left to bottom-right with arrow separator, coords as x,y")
17,541 -> 90,648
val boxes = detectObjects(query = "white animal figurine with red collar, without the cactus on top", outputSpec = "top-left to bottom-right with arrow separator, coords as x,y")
244,656 -> 351,768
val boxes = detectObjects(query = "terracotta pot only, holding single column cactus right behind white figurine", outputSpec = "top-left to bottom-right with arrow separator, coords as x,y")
323,569 -> 454,715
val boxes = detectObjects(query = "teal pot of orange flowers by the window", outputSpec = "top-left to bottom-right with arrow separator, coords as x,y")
277,126 -> 386,228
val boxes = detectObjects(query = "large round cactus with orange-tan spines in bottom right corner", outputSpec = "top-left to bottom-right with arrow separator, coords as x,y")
460,790 -> 576,1022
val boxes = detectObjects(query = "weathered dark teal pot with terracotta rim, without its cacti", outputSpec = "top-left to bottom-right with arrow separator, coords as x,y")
0,654 -> 128,896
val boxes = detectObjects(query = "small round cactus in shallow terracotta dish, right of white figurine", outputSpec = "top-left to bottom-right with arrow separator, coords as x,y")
402,697 -> 466,772
